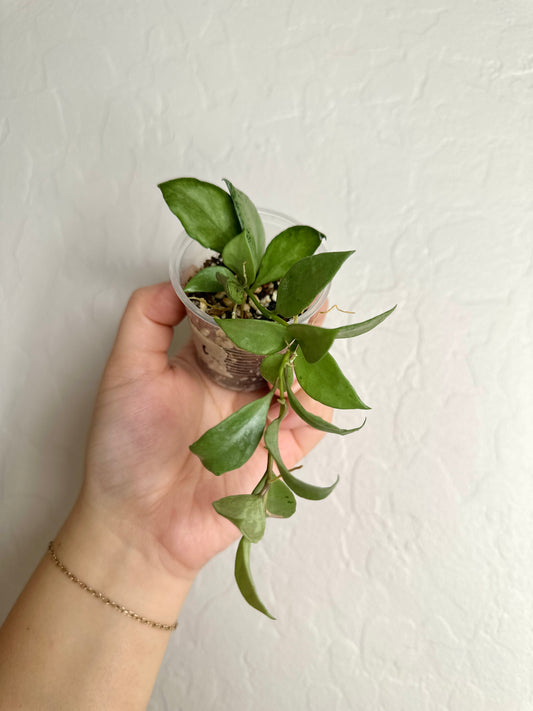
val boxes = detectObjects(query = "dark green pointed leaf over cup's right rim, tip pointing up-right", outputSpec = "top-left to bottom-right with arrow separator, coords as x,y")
276,250 -> 353,317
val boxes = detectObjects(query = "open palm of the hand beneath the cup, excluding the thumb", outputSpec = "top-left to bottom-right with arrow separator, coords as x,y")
83,336 -> 326,571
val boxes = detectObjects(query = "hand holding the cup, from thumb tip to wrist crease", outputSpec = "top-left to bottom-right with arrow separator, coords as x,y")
80,282 -> 331,578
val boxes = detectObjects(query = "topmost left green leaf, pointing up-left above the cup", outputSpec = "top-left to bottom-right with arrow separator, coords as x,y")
158,178 -> 241,252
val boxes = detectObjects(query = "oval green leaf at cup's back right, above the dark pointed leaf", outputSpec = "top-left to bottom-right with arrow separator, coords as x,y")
251,225 -> 325,286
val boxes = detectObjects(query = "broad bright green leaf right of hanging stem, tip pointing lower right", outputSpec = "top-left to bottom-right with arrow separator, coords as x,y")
294,347 -> 370,410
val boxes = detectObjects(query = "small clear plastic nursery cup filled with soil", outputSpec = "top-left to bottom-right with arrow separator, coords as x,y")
170,209 -> 329,391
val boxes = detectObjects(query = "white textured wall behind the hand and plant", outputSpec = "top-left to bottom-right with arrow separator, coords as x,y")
0,0 -> 533,711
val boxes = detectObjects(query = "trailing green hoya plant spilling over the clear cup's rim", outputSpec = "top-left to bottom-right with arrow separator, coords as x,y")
159,178 -> 396,617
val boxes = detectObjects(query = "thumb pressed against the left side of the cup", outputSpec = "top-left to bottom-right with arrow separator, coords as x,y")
110,282 -> 185,375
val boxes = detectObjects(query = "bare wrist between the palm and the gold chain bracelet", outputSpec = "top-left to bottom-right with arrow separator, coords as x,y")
51,498 -> 194,624
